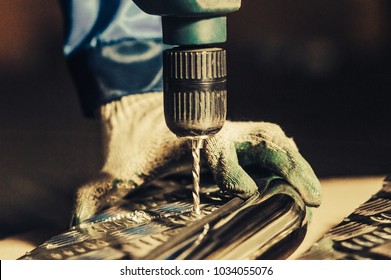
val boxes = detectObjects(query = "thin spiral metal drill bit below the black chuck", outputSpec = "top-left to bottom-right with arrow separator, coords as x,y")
191,139 -> 204,215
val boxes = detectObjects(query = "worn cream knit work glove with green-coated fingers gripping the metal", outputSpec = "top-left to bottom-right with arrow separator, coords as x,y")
71,93 -> 321,225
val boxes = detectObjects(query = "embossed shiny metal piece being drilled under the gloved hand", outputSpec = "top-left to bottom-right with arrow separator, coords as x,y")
21,178 -> 306,260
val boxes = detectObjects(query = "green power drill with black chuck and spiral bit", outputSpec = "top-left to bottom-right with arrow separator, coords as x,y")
134,0 -> 241,214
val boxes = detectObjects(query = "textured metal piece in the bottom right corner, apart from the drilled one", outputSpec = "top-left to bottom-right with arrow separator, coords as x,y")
300,177 -> 391,259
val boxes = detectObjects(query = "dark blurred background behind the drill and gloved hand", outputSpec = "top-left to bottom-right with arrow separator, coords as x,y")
0,0 -> 391,235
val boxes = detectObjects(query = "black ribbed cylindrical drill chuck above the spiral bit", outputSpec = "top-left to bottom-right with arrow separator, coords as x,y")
163,47 -> 227,139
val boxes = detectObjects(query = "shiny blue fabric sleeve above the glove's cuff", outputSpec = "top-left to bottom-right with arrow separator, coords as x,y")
60,0 -> 164,116
